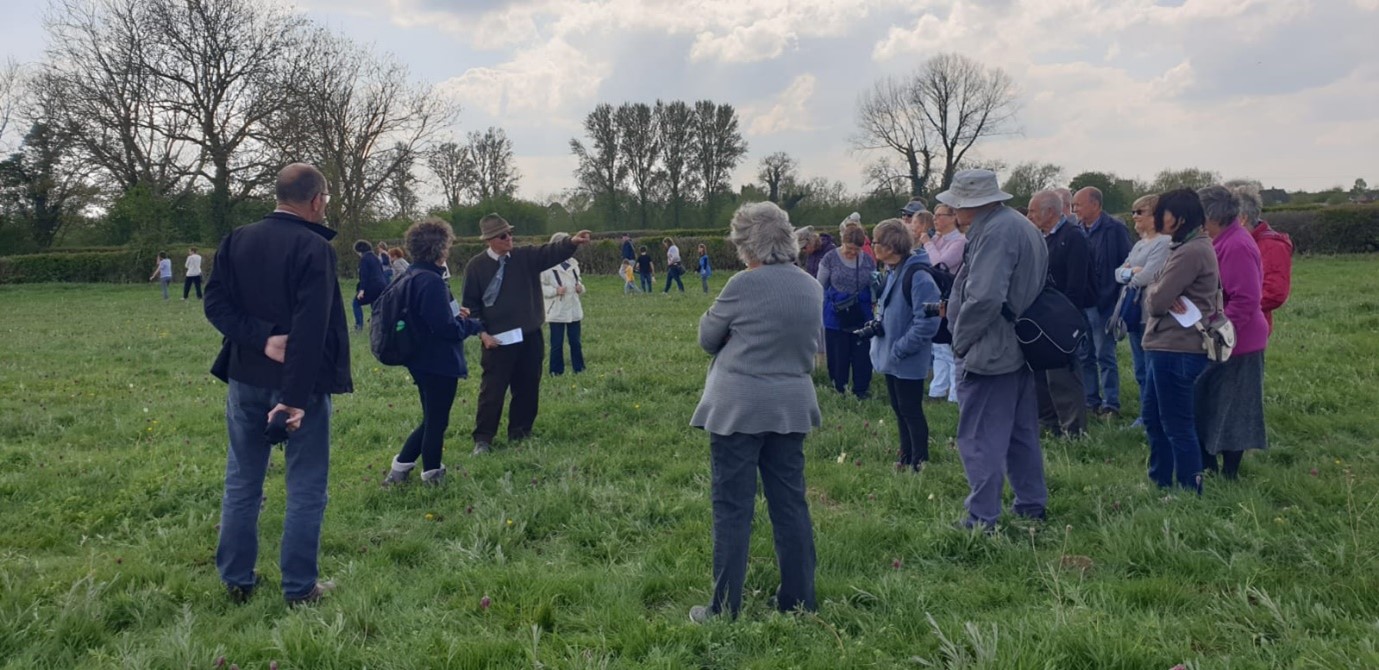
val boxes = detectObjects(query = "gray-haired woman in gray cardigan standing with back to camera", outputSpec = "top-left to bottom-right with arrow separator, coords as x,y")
690,203 -> 823,622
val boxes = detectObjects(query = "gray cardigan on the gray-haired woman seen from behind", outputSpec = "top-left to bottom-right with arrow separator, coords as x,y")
690,265 -> 823,436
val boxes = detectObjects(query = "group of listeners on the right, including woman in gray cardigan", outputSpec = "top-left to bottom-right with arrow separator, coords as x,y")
690,170 -> 1292,620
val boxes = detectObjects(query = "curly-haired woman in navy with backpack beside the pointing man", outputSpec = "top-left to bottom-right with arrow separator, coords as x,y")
383,216 -> 483,487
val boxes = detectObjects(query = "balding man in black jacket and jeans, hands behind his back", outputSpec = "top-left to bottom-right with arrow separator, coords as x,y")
205,163 -> 354,605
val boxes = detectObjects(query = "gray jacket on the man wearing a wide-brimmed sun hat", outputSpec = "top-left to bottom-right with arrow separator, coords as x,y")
947,205 -> 1048,375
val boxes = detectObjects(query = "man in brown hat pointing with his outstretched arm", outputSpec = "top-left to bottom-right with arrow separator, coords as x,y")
461,214 -> 589,455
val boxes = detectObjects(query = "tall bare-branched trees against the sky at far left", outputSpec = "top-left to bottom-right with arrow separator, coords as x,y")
0,0 -> 517,247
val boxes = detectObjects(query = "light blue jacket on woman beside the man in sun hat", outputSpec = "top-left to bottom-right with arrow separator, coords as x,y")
872,248 -> 940,379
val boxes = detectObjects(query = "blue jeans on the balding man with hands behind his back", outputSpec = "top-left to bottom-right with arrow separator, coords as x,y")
215,379 -> 331,600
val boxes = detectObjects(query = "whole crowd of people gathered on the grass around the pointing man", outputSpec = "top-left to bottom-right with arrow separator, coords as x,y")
205,164 -> 1288,622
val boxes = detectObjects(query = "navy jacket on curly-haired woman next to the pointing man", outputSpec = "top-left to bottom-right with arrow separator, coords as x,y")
405,263 -> 483,378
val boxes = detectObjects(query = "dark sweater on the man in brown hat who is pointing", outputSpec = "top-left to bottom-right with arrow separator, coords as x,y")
461,240 -> 575,335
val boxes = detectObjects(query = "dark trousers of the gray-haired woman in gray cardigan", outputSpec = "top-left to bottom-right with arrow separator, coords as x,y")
709,433 -> 818,616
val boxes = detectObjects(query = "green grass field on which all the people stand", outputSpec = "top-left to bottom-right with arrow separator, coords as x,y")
0,256 -> 1379,670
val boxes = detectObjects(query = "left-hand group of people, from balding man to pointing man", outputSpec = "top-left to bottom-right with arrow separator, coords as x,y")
205,163 -> 589,605
